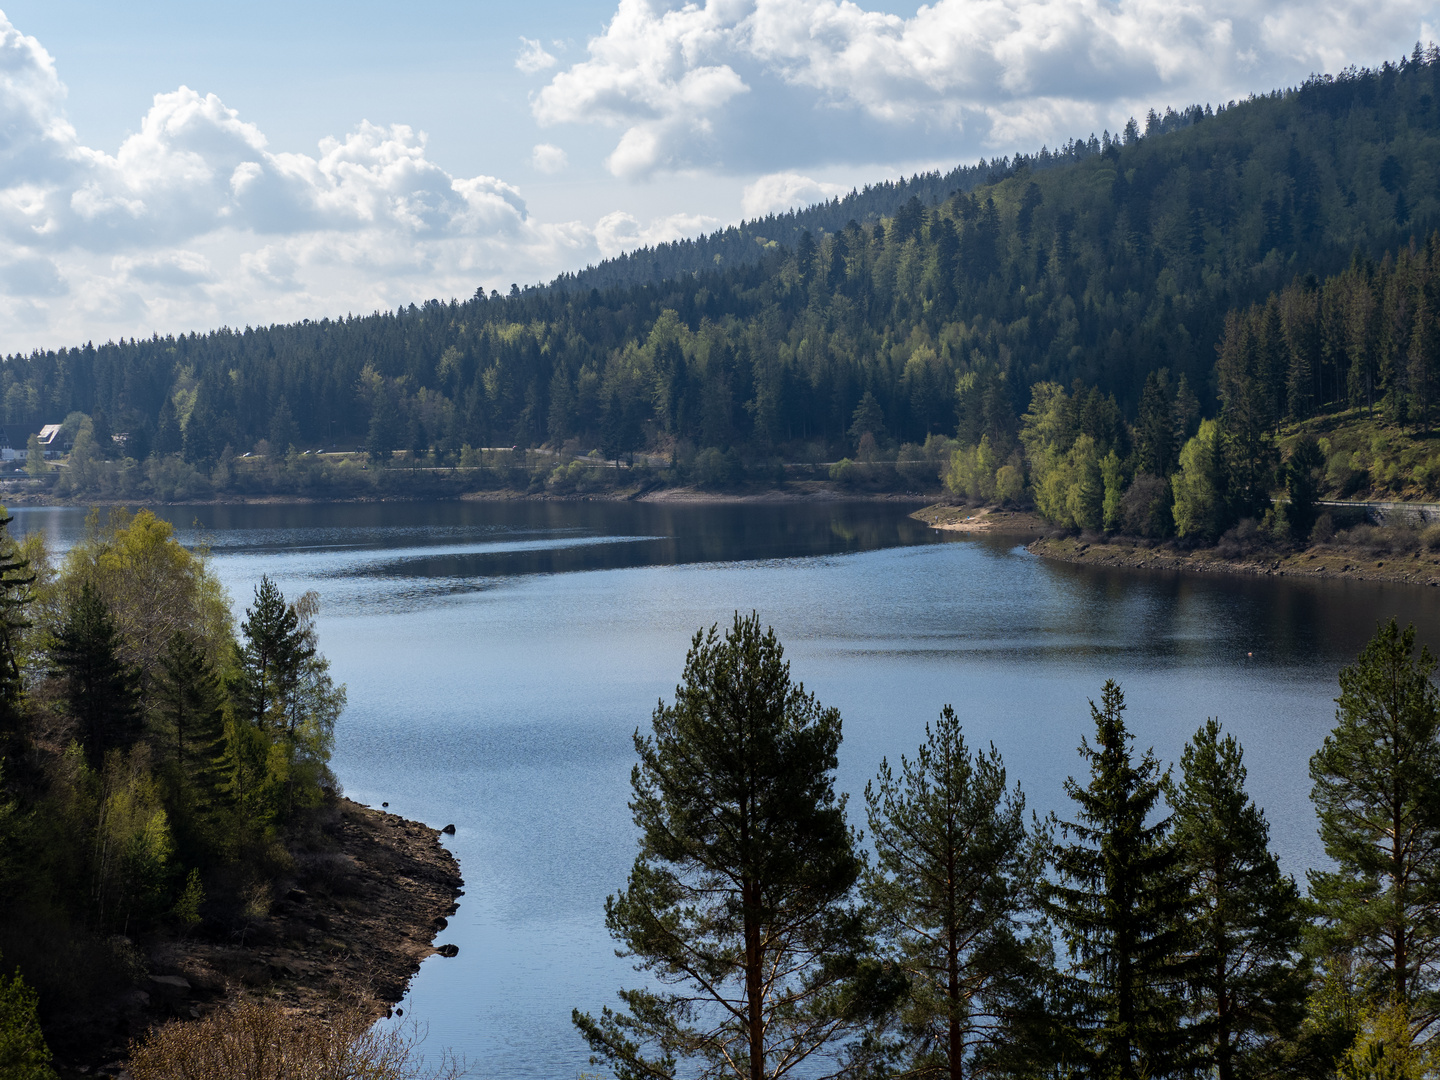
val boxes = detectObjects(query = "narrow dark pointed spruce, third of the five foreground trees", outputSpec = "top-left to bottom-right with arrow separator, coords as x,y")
1043,680 -> 1195,1080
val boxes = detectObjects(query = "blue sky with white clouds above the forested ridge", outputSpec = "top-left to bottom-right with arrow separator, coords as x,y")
0,0 -> 1437,351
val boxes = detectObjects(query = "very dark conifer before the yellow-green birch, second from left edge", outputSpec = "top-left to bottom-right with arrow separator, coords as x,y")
50,582 -> 140,765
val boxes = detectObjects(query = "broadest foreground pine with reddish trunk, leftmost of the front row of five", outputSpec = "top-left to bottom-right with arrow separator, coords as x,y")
575,613 -> 861,1080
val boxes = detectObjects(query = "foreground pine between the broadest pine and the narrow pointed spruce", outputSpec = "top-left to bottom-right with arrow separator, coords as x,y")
865,706 -> 1043,1080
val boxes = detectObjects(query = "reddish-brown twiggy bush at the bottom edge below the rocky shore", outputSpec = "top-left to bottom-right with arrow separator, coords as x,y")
130,1001 -> 461,1080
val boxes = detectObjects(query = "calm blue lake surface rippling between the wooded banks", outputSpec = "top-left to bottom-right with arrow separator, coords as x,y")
14,503 -> 1440,1077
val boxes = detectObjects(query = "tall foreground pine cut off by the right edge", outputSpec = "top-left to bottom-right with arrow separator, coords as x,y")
1310,619 -> 1440,1037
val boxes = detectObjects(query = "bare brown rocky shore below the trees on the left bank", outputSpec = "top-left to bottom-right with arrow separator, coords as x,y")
46,799 -> 464,1080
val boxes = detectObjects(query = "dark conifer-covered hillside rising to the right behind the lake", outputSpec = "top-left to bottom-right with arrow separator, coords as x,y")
0,48 -> 1440,495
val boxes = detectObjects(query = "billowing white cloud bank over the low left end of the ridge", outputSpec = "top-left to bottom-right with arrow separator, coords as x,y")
0,14 -> 708,353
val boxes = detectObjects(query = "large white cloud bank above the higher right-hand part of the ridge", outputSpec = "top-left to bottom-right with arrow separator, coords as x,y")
531,0 -> 1430,177
